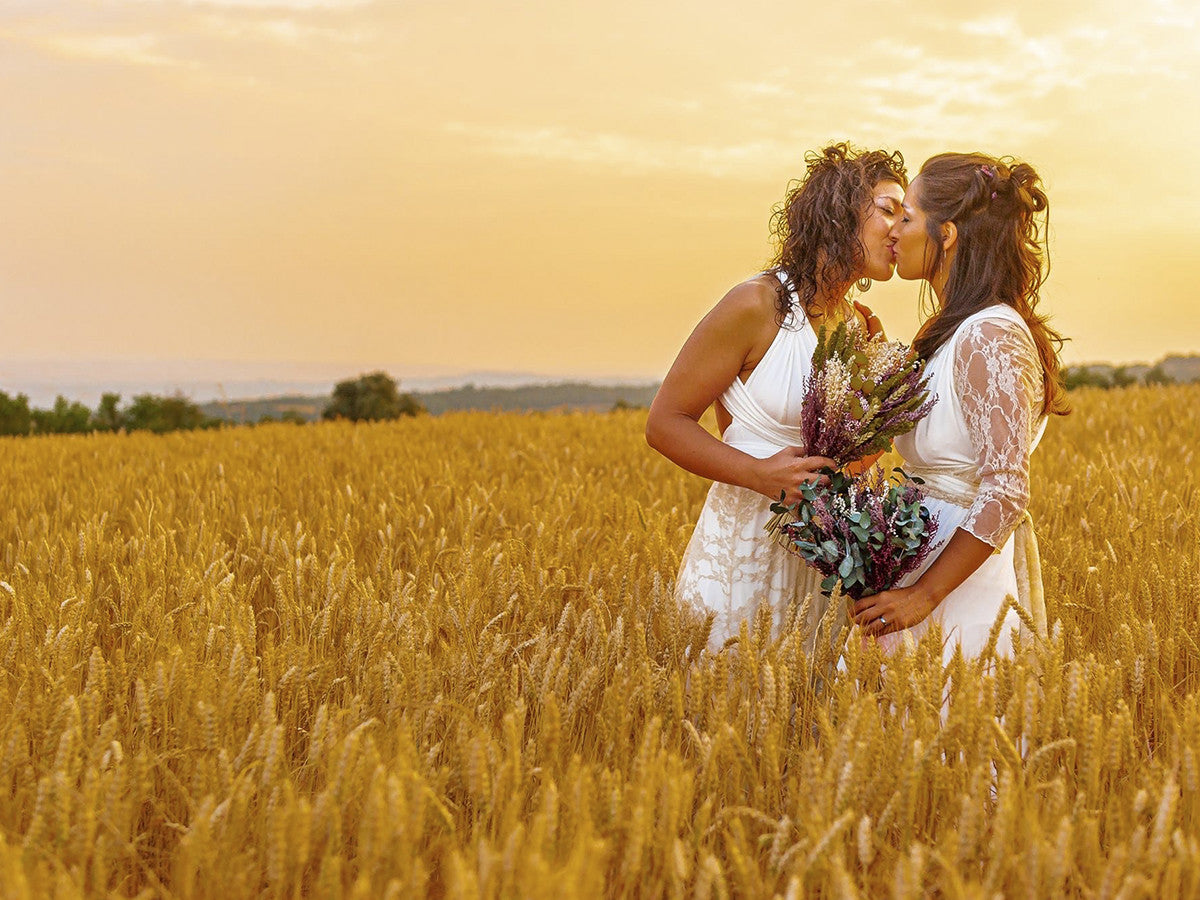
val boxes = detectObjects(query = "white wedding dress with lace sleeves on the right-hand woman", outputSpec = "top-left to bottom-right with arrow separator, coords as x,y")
880,304 -> 1045,661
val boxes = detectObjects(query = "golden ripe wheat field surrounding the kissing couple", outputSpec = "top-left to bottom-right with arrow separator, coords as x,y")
0,386 -> 1200,900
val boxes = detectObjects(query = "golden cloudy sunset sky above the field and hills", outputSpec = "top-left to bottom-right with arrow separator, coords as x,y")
0,0 -> 1200,377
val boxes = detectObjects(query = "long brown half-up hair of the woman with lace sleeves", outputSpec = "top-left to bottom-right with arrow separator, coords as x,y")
913,154 -> 1070,415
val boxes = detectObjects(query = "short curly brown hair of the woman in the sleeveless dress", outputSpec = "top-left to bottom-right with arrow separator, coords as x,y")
770,142 -> 908,326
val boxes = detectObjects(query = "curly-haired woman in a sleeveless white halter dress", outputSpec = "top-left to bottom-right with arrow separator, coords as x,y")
646,144 -> 907,652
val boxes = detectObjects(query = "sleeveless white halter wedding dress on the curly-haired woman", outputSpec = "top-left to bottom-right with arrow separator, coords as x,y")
676,276 -> 827,652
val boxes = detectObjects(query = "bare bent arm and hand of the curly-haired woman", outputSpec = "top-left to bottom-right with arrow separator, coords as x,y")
646,281 -> 834,503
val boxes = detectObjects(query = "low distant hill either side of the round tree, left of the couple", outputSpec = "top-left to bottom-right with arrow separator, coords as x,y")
200,382 -> 659,422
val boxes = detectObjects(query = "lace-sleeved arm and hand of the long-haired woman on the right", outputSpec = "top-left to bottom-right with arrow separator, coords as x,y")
854,320 -> 1042,635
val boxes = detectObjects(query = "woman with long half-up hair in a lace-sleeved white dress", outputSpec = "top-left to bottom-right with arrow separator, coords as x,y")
854,154 -> 1068,659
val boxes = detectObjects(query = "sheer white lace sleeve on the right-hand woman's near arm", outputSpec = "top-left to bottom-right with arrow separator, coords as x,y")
954,319 -> 1043,547
